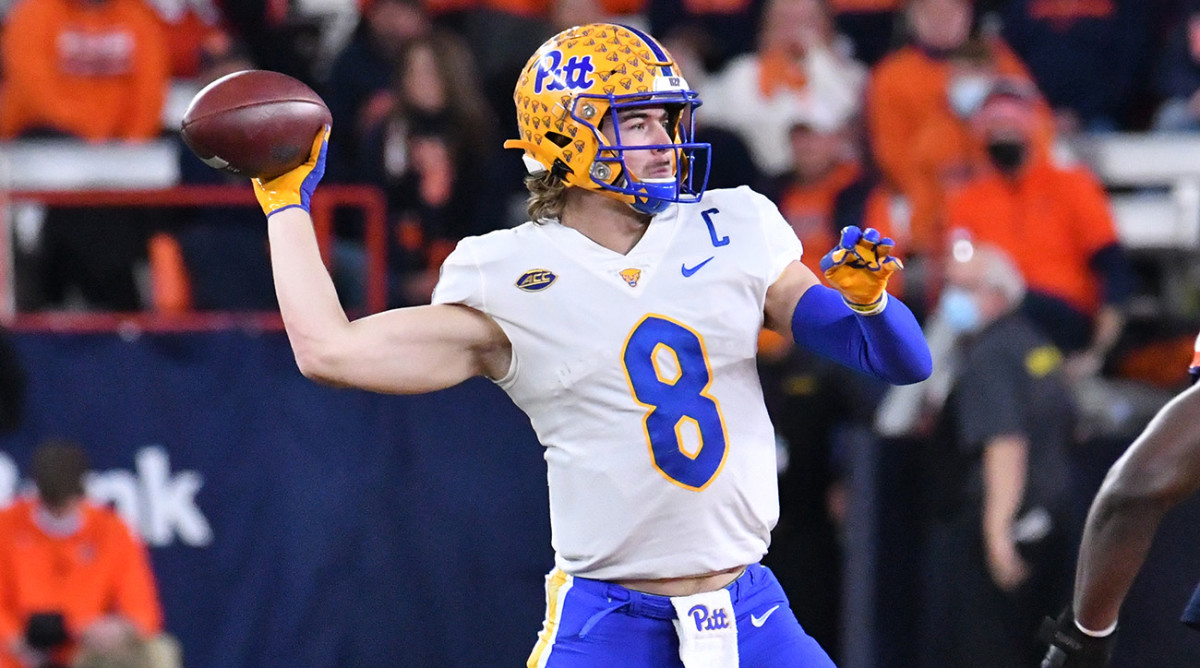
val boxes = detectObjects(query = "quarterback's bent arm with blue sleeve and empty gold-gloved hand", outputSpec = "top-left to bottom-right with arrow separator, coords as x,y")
766,228 -> 932,385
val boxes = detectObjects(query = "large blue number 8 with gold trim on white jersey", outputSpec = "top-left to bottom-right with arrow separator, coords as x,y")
623,314 -> 728,492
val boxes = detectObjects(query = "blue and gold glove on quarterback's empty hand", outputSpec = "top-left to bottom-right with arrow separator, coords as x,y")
821,225 -> 904,315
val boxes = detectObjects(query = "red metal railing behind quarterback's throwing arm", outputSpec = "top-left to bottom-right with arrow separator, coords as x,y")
0,185 -> 388,333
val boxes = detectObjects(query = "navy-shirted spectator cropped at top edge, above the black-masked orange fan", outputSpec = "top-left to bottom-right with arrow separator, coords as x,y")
1002,0 -> 1148,133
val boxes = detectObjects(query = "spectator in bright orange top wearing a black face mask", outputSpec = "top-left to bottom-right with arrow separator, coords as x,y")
949,80 -> 1133,377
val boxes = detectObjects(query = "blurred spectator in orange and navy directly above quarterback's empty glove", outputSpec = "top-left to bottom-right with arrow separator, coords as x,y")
773,106 -> 870,276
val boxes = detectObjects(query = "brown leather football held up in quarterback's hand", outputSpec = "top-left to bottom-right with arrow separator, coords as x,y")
180,70 -> 331,180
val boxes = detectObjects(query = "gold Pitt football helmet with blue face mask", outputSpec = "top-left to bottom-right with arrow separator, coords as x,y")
504,23 -> 710,213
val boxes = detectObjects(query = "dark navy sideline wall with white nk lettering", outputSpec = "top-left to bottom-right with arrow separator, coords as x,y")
0,331 -> 552,668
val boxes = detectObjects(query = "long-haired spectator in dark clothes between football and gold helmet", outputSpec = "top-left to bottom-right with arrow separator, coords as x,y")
352,34 -> 498,305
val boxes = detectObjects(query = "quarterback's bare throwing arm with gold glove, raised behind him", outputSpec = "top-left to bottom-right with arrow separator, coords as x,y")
254,128 -> 511,393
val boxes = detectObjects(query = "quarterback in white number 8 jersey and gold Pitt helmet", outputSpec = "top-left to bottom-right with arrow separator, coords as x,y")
254,24 -> 931,668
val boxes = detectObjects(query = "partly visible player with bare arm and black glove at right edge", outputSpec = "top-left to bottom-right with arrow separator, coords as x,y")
1042,337 -> 1200,668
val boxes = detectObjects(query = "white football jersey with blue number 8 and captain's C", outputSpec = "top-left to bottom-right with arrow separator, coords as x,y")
433,187 -> 800,580
